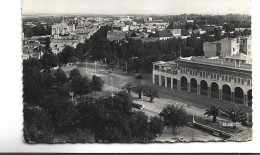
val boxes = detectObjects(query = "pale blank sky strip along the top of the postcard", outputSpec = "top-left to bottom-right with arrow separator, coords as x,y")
22,0 -> 251,15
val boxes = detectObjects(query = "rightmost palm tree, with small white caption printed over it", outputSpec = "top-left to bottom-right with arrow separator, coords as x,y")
221,106 -> 246,130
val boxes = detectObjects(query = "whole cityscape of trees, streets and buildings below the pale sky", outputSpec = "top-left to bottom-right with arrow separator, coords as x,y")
21,0 -> 253,143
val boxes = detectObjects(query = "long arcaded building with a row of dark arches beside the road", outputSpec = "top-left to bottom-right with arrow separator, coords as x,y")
153,57 -> 252,106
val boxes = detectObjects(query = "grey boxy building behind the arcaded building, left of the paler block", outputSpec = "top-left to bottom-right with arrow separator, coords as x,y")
203,42 -> 221,57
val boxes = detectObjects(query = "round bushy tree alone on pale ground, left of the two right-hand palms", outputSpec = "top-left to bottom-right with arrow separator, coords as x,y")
159,105 -> 188,134
